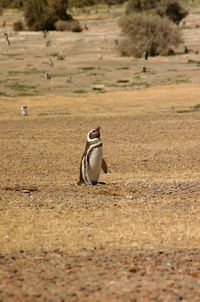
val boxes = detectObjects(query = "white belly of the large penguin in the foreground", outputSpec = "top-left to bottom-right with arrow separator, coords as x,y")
88,146 -> 103,181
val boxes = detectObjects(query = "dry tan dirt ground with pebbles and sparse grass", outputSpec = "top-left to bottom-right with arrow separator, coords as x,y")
0,2 -> 200,302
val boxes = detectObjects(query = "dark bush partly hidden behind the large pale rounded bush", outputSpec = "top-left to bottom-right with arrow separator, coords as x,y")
156,0 -> 188,24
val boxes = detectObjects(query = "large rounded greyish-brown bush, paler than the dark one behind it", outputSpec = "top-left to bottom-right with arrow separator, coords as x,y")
119,14 -> 182,58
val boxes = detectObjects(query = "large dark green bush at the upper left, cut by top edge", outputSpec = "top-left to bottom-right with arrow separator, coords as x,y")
24,0 -> 72,30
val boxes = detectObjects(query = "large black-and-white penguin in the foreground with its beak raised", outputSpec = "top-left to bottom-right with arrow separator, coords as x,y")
77,127 -> 108,185
